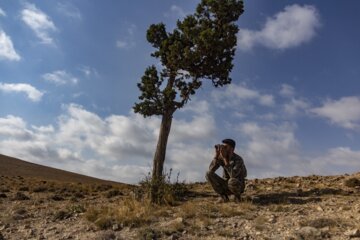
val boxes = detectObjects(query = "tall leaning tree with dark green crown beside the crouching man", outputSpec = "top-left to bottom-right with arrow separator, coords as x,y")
133,0 -> 244,203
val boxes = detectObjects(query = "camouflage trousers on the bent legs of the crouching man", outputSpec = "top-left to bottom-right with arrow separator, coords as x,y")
206,171 -> 245,197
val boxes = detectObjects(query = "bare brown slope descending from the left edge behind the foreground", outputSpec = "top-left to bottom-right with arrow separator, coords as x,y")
0,154 -> 125,184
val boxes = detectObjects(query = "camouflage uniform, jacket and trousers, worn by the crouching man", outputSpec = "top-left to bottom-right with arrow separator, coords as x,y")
206,153 -> 247,200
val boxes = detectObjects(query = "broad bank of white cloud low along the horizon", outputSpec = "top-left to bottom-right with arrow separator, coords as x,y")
0,94 -> 360,183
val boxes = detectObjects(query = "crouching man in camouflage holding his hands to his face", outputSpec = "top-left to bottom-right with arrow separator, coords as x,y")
206,139 -> 247,202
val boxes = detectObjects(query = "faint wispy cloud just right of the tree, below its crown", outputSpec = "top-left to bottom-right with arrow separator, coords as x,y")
211,83 -> 275,107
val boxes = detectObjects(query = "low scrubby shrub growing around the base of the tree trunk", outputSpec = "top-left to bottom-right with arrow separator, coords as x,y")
140,169 -> 188,205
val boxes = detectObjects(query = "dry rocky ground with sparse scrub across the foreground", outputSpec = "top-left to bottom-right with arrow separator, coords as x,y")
0,173 -> 360,240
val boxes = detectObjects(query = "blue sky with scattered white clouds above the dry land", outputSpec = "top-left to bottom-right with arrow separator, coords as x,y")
0,0 -> 360,183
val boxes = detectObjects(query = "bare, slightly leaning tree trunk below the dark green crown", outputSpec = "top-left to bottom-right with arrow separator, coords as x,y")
150,113 -> 172,203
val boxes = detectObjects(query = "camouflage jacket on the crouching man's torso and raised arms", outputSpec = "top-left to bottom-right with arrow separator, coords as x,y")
209,153 -> 247,180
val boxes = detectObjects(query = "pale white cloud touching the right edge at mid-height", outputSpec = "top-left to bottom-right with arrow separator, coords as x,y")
310,96 -> 360,129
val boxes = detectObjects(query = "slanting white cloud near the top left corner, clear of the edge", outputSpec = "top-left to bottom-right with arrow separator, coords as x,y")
21,4 -> 56,44
